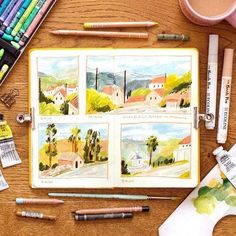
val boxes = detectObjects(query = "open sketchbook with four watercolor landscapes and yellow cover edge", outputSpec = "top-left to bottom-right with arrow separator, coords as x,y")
29,49 -> 199,188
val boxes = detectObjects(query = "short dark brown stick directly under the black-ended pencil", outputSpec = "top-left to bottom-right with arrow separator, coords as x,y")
75,212 -> 133,221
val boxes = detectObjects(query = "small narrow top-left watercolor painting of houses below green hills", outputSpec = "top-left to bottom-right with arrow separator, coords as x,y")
37,57 -> 79,116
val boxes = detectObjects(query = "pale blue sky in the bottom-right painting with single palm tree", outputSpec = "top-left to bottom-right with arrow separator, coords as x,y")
122,123 -> 191,141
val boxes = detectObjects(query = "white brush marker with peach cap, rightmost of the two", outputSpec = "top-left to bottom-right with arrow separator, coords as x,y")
217,48 -> 234,143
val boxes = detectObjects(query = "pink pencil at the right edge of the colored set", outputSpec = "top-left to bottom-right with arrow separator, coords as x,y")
19,0 -> 55,46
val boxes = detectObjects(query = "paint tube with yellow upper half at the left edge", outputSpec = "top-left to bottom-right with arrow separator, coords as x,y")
0,114 -> 21,168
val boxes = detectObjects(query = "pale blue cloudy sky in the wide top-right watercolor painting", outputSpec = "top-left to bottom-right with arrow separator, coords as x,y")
87,56 -> 191,79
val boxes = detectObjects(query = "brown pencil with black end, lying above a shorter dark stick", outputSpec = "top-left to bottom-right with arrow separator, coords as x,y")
72,206 -> 149,215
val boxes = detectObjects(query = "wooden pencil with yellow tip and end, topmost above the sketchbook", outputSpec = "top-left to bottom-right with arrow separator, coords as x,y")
84,21 -> 158,29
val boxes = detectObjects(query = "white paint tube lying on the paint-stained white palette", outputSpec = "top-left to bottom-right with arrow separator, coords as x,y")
213,146 -> 236,188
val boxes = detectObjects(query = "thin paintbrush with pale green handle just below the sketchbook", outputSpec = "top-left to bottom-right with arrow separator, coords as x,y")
48,193 -> 179,200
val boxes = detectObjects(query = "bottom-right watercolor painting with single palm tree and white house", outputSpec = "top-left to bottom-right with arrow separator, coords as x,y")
121,123 -> 191,178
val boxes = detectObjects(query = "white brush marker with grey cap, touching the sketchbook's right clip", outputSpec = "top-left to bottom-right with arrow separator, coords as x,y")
205,34 -> 219,129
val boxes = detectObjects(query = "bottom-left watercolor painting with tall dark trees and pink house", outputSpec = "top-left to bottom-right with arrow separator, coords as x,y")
39,123 -> 108,178
